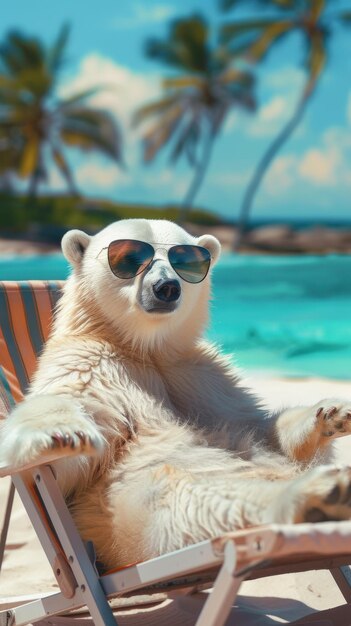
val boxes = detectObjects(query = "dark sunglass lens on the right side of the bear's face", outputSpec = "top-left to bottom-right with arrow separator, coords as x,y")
168,246 -> 211,283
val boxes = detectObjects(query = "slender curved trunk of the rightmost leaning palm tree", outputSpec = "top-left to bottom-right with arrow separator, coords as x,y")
233,92 -> 309,250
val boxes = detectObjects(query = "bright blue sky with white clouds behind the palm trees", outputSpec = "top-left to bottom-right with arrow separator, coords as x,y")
0,0 -> 351,221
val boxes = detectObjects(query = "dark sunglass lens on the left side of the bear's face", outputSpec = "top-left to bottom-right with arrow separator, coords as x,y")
108,239 -> 154,278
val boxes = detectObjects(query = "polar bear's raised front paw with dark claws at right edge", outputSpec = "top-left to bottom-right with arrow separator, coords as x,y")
275,399 -> 351,463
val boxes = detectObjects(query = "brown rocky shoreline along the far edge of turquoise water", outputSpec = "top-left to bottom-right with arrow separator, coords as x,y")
0,222 -> 351,257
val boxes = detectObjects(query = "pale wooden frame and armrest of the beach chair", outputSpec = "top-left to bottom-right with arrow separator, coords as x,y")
0,452 -> 351,626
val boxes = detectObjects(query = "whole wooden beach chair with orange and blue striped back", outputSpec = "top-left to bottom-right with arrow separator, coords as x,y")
0,281 -> 351,626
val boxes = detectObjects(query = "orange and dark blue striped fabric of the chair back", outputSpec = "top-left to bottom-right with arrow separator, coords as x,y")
0,281 -> 64,418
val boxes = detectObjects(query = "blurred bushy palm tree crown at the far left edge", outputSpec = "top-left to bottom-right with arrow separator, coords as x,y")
0,25 -> 122,196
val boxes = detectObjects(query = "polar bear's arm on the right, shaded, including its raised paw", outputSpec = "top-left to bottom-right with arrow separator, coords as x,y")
166,342 -> 351,463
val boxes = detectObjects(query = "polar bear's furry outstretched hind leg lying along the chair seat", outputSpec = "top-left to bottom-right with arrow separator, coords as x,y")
93,458 -> 351,567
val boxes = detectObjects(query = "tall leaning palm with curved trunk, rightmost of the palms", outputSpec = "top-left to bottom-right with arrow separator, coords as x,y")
221,0 -> 351,247
